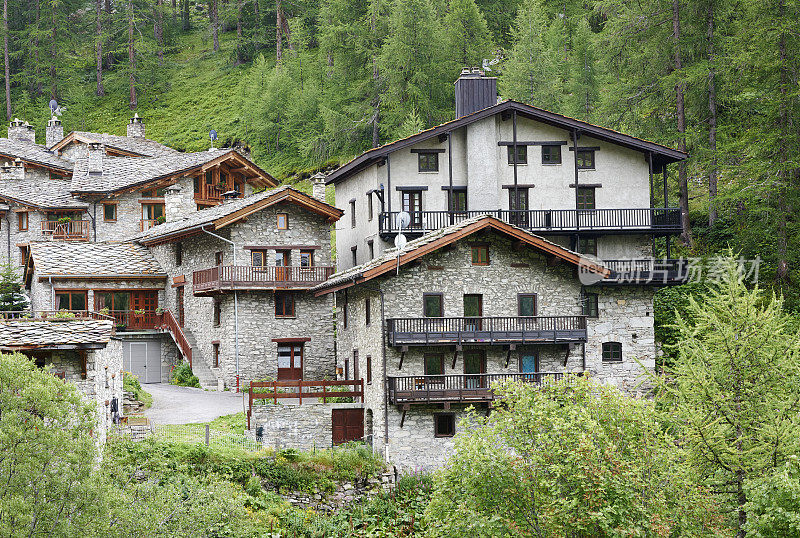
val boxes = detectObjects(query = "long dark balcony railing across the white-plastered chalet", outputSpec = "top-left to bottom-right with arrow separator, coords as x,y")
378,207 -> 681,236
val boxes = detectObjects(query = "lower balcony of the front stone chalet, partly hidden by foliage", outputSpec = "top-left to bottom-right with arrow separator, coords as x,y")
388,372 -> 576,405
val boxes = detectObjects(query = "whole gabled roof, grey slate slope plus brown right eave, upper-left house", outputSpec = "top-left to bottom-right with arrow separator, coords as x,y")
71,149 -> 278,195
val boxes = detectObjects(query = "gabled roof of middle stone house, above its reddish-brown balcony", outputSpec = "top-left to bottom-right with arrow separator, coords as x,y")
133,185 -> 343,246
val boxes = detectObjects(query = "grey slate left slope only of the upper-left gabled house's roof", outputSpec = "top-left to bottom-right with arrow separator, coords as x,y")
71,149 -> 234,193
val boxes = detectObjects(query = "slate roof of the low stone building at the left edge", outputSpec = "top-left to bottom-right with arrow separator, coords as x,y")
0,319 -> 114,350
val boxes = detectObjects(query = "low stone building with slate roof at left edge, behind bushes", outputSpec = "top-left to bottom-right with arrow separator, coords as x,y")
0,319 -> 122,444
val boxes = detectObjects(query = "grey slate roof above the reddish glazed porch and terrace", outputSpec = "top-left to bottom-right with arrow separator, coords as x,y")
30,241 -> 166,278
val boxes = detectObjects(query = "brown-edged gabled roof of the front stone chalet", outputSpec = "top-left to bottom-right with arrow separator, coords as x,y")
312,215 -> 609,295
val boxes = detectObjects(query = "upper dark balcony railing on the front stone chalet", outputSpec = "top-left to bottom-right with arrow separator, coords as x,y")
386,316 -> 586,346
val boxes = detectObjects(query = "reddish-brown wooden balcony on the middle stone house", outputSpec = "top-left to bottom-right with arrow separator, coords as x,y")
192,265 -> 334,296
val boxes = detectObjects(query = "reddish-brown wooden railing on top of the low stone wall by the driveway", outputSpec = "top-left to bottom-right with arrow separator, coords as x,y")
247,379 -> 364,430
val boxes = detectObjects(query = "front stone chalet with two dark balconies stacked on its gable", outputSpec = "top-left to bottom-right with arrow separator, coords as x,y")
314,215 -> 656,467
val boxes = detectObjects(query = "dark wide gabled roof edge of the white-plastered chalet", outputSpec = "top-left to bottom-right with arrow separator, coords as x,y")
325,100 -> 688,184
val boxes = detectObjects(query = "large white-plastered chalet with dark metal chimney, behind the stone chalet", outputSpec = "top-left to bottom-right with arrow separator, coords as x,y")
326,69 -> 687,270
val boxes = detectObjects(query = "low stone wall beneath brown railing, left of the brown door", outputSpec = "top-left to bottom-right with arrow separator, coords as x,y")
249,403 -> 362,450
